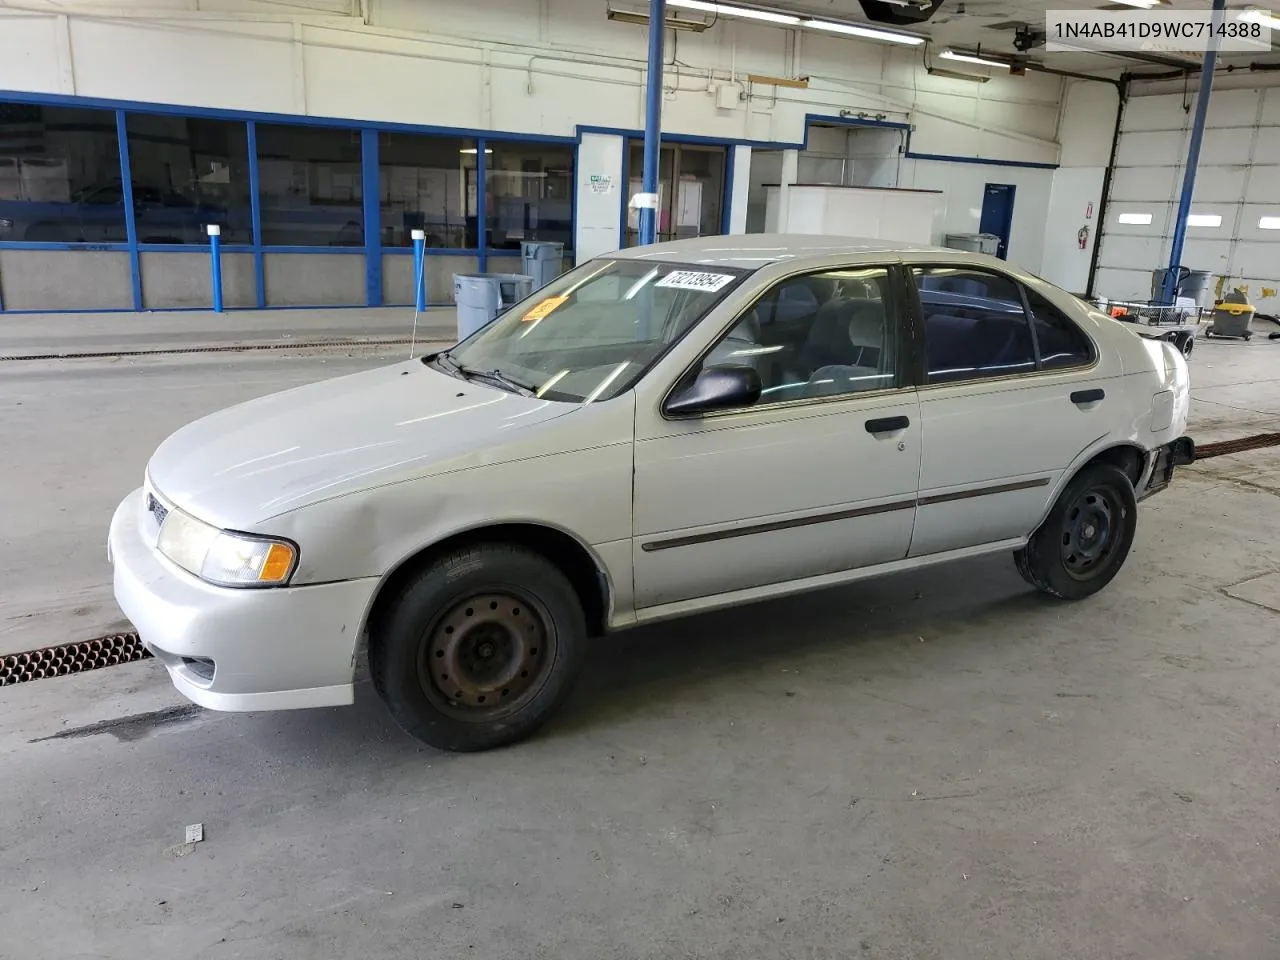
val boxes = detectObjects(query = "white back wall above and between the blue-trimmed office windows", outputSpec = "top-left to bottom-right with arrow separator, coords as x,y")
0,0 -> 1080,269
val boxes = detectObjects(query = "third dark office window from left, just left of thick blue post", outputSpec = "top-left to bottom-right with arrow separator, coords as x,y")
257,123 -> 365,247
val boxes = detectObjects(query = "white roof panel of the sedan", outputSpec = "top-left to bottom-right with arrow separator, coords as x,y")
608,233 -> 962,270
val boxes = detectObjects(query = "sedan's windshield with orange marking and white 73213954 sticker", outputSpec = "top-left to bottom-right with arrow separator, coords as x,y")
431,259 -> 749,403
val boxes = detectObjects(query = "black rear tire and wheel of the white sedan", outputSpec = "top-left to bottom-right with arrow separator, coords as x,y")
1014,463 -> 1138,600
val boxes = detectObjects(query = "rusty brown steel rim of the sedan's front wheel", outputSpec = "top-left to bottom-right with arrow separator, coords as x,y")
419,588 -> 557,722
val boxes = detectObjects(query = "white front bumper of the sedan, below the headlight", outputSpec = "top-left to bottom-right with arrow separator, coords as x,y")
108,489 -> 378,710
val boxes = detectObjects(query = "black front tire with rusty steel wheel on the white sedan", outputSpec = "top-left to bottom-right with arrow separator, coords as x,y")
369,544 -> 588,753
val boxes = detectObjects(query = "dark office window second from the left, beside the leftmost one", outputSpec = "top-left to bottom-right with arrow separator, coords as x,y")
125,114 -> 253,243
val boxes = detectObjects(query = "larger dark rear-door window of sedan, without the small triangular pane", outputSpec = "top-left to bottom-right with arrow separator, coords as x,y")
913,266 -> 1036,383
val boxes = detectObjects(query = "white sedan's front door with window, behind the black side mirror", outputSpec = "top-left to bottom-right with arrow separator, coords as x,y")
634,266 -> 920,616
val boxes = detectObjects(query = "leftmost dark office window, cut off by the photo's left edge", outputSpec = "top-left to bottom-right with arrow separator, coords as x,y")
0,104 -> 127,243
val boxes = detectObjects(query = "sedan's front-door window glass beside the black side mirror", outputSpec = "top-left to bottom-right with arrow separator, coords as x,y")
703,268 -> 900,403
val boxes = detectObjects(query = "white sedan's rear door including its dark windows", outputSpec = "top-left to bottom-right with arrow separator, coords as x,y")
911,265 -> 1115,557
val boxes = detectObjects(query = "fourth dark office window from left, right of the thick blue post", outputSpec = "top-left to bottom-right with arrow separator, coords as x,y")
378,133 -> 477,250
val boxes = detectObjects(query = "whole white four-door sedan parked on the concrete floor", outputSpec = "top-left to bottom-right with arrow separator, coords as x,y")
110,236 -> 1194,750
